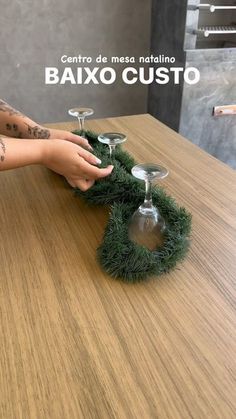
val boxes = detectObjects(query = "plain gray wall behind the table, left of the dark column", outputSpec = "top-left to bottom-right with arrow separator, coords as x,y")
0,0 -> 151,122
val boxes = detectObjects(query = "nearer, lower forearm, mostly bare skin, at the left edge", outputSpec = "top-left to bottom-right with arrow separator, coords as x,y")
0,137 -> 44,171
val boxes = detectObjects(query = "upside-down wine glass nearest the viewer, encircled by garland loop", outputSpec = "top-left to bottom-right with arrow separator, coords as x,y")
129,163 -> 168,250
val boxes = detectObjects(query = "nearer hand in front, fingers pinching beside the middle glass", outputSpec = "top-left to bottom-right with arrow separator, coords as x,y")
42,139 -> 113,191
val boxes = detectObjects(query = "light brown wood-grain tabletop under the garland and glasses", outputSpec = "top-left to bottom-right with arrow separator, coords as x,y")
0,115 -> 236,419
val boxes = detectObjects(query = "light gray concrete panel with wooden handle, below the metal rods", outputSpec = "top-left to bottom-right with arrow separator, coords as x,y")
179,48 -> 236,169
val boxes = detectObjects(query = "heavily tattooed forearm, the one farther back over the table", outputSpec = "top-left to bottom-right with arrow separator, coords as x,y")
0,100 -> 50,139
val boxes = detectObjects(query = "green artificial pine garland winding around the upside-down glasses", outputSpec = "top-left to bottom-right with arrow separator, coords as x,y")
74,131 -> 191,282
